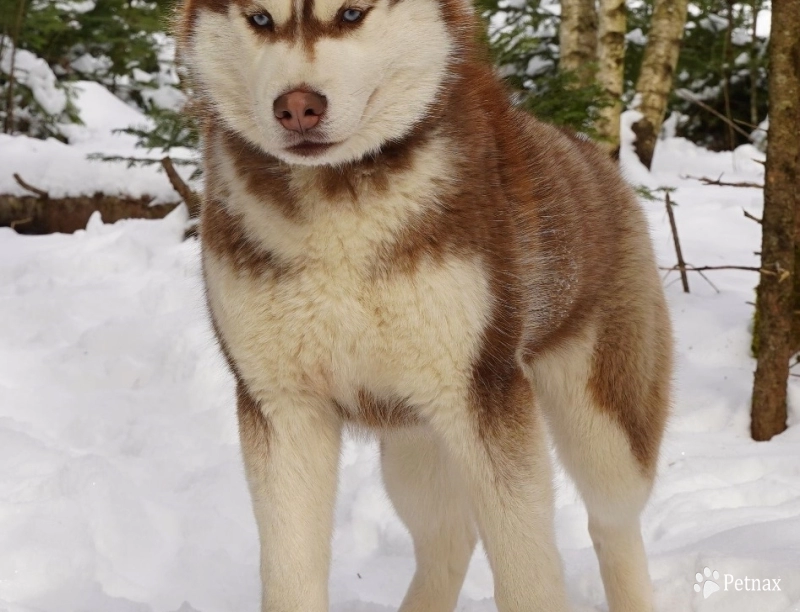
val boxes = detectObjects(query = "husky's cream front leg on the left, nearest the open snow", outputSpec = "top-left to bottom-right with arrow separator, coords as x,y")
238,383 -> 342,612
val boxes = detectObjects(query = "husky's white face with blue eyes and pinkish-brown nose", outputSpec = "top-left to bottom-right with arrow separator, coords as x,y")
184,0 -> 454,165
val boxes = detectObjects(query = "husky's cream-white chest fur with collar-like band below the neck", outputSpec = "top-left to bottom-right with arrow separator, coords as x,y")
205,138 -> 491,418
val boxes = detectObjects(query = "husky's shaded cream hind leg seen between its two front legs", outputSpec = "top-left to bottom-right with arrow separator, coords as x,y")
381,427 -> 476,612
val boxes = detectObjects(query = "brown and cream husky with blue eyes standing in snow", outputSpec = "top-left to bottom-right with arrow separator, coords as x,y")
179,0 -> 672,612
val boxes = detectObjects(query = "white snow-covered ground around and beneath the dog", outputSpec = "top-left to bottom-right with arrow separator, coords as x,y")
0,111 -> 800,612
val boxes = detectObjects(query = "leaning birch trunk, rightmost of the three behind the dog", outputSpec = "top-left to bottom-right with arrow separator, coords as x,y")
633,0 -> 688,168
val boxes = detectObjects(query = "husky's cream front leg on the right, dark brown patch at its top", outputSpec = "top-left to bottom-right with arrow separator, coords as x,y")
432,370 -> 568,612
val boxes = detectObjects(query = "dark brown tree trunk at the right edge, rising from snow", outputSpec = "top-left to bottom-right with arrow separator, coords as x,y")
751,0 -> 800,440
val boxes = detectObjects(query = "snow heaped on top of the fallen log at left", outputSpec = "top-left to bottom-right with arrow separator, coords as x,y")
0,79 -> 194,203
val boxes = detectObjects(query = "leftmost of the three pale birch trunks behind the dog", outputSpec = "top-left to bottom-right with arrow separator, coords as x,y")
558,0 -> 597,87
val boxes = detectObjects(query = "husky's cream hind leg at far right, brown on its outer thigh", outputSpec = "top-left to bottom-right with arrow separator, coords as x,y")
534,330 -> 669,612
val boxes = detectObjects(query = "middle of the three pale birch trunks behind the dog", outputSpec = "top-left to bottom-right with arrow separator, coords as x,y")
597,0 -> 627,156
